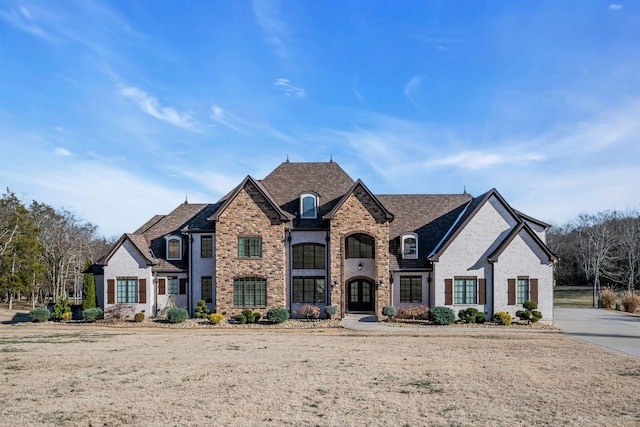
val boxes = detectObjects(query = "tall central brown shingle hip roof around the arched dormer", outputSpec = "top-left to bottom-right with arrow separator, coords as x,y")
261,162 -> 354,227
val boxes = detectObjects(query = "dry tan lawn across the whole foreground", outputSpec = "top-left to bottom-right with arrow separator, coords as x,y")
0,312 -> 640,426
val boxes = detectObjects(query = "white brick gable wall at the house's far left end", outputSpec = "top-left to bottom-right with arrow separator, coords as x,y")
102,240 -> 155,316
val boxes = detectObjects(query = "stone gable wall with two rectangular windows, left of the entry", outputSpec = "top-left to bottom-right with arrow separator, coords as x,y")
215,183 -> 287,317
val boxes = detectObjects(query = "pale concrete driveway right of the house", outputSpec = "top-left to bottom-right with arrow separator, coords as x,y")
554,308 -> 640,358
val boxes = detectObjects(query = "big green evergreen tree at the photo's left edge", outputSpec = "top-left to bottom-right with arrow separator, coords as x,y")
0,189 -> 44,310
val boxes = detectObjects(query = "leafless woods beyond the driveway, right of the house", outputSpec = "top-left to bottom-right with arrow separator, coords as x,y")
548,210 -> 640,295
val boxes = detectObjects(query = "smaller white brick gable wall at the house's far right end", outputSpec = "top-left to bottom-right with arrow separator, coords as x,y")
494,230 -> 553,323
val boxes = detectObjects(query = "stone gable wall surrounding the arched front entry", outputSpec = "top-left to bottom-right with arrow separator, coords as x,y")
330,187 -> 390,317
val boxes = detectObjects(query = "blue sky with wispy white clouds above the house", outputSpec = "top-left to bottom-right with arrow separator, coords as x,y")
0,0 -> 640,236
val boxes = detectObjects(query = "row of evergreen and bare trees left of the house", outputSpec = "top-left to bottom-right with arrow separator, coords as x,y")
0,189 -> 114,309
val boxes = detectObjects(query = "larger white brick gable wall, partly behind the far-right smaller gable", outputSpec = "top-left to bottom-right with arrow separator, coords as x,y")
432,197 -> 517,316
